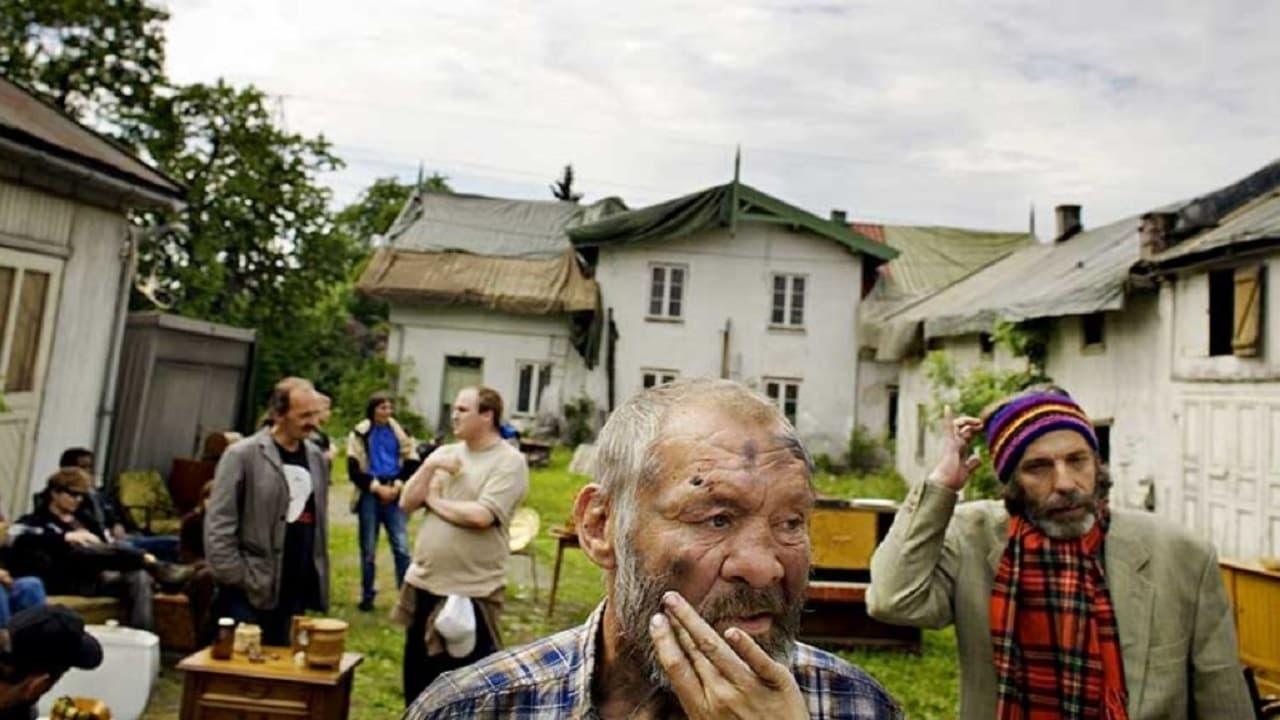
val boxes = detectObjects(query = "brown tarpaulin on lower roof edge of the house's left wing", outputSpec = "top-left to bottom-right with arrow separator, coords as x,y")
358,247 -> 599,315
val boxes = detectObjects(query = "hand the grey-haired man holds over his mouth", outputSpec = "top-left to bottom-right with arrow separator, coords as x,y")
649,592 -> 809,720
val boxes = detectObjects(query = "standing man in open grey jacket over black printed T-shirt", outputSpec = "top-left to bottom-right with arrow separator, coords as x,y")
205,378 -> 329,644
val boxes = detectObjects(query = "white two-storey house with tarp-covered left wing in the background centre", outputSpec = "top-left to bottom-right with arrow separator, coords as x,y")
361,182 -> 896,454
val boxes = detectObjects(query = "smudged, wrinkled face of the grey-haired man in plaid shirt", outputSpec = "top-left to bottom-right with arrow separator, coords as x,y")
614,406 -> 814,682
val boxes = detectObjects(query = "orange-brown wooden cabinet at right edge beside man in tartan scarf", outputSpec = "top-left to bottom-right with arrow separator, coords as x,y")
1221,560 -> 1280,694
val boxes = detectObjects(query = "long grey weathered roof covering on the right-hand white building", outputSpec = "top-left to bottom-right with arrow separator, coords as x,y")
877,217 -> 1139,360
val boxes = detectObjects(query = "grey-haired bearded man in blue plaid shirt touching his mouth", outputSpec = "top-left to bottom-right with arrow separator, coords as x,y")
406,380 -> 899,720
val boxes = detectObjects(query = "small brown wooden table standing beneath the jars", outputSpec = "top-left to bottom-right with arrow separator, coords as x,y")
178,647 -> 364,720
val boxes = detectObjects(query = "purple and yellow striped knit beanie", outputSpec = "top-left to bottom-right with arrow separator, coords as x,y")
986,391 -> 1098,483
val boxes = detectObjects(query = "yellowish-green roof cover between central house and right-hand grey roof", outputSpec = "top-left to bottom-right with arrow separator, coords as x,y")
854,223 -> 1036,347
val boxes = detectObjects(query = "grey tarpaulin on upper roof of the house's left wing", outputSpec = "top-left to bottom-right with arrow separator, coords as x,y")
387,185 -> 626,260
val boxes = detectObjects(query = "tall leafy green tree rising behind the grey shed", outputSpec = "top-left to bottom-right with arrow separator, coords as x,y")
136,81 -> 364,397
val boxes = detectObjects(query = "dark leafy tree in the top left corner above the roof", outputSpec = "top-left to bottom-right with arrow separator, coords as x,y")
0,0 -> 169,136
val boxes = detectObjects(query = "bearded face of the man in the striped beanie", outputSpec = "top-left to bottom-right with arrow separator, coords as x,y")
1012,430 -> 1098,538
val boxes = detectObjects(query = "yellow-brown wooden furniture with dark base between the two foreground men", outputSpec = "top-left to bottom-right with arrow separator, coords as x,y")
800,498 -> 922,652
